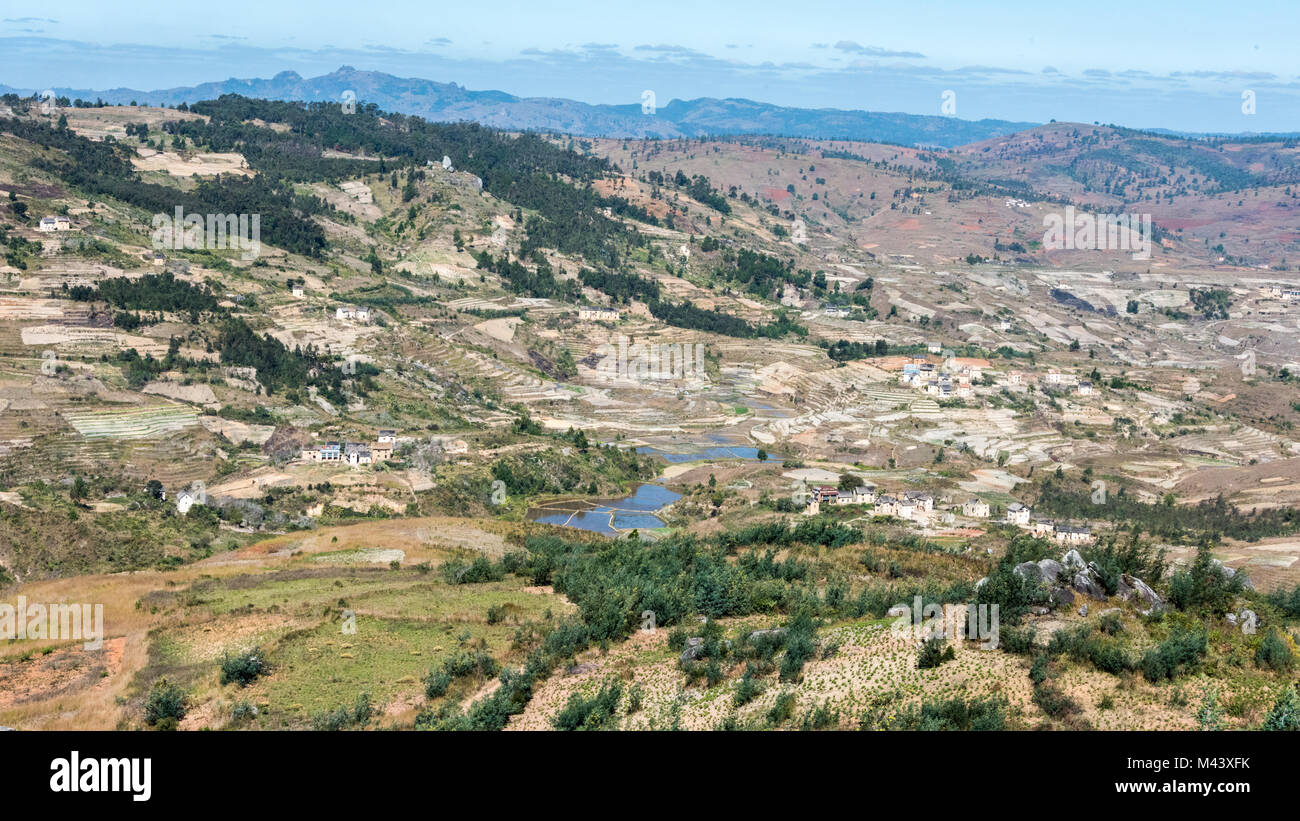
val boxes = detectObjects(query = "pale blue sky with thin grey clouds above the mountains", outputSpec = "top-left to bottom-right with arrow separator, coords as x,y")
0,0 -> 1300,133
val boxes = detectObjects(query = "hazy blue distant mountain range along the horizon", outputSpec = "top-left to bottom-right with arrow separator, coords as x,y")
0,66 -> 1037,148
